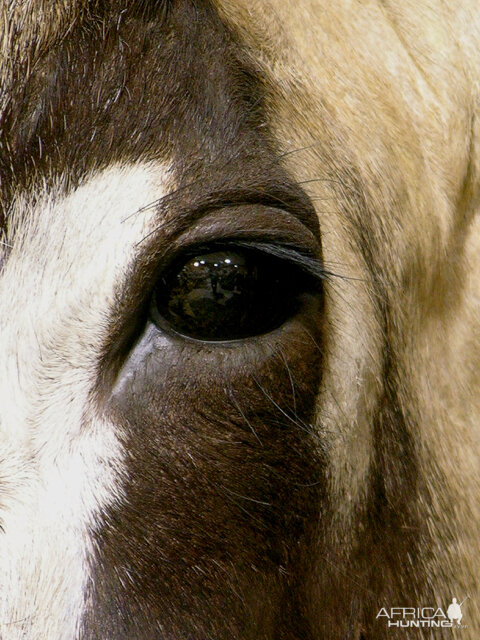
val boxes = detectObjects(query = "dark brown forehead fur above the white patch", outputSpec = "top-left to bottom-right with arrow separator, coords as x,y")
0,1 -> 265,203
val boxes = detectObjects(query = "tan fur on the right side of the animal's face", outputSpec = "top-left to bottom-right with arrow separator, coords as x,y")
213,0 -> 480,640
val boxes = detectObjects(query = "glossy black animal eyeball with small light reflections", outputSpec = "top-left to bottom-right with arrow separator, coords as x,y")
151,247 -> 316,342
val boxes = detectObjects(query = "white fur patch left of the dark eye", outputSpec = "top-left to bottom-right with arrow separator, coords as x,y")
0,165 -> 171,640
